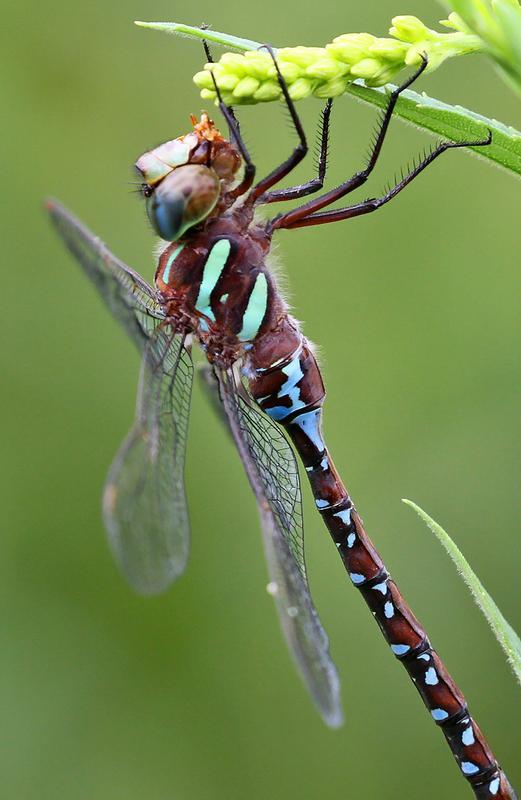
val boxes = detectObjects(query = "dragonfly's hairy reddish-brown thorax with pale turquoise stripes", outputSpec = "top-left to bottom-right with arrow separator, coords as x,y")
155,212 -> 287,365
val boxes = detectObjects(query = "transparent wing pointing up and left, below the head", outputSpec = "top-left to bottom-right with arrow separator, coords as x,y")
46,200 -> 165,349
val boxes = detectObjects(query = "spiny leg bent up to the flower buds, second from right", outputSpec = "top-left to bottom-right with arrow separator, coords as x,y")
272,56 -> 428,228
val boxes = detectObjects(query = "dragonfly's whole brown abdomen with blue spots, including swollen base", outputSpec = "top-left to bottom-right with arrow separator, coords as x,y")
250,334 -> 507,797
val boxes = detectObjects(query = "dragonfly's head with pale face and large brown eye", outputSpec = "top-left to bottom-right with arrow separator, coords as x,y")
136,114 -> 241,241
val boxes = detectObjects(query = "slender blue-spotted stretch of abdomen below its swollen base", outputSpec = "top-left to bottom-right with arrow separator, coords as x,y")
281,418 -> 507,797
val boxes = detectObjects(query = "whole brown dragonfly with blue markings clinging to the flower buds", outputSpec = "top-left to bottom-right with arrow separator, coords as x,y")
47,48 -> 515,798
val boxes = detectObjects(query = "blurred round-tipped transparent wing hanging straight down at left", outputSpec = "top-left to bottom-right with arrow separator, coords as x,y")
103,327 -> 193,594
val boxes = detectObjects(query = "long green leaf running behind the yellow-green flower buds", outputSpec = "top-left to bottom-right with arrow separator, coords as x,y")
136,19 -> 521,175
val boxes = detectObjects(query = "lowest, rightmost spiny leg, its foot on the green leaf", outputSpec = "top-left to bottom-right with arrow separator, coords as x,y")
273,131 -> 492,228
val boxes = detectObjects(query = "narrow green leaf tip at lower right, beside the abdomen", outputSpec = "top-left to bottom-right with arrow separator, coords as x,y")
403,500 -> 521,683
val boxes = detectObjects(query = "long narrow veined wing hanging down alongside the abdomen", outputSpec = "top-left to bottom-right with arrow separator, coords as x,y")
217,370 -> 343,727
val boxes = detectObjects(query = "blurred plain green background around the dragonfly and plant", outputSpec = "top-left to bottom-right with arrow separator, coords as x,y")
0,0 -> 521,800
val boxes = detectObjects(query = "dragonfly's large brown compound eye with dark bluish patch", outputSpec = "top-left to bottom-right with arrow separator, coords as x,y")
147,164 -> 221,242
